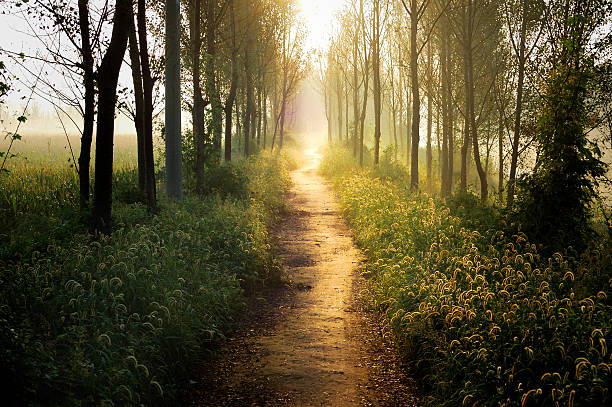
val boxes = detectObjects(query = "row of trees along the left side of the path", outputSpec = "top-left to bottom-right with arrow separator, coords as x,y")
5,0 -> 307,233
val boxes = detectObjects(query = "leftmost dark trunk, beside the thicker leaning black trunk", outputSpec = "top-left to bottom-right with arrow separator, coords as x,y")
78,0 -> 96,208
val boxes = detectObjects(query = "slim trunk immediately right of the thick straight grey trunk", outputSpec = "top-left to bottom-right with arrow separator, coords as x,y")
190,0 -> 210,194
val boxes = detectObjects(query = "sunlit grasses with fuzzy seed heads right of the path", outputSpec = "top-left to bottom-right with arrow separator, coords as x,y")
322,150 -> 612,406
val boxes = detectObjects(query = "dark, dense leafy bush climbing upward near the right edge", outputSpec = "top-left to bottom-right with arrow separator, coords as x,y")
516,61 -> 606,252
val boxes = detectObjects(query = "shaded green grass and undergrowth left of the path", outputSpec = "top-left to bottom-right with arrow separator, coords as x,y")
0,141 -> 289,406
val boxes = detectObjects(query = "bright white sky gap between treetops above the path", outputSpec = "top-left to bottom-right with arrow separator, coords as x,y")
298,0 -> 346,50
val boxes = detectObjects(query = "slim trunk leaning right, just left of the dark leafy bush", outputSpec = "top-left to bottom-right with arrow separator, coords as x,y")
507,0 -> 527,207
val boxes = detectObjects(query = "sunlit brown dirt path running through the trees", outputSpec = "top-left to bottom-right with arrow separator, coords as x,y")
193,150 -> 417,406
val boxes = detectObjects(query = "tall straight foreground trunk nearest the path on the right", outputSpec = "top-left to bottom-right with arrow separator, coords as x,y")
410,0 -> 421,191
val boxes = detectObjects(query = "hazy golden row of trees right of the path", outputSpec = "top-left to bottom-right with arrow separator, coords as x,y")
318,0 -> 612,214
